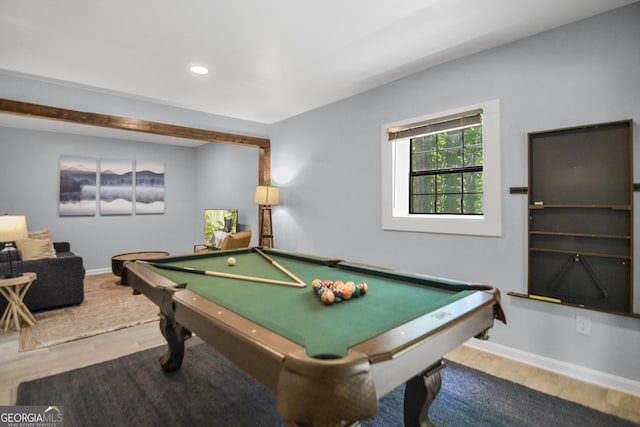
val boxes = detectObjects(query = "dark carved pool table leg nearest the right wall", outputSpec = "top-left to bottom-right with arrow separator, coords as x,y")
404,360 -> 444,427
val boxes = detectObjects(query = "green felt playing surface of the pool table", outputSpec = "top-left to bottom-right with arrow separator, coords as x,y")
149,250 -> 474,358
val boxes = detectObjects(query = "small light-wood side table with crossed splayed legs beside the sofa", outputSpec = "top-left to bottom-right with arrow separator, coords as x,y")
0,273 -> 38,332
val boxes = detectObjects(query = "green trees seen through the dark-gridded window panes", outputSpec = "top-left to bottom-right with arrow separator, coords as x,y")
409,124 -> 483,215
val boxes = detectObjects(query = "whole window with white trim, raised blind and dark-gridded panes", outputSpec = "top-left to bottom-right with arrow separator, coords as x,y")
382,100 -> 501,236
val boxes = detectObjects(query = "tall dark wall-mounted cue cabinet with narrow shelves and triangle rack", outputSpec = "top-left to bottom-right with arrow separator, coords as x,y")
528,120 -> 633,314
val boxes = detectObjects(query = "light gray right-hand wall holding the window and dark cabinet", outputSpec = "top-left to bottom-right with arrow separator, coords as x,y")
271,3 -> 640,380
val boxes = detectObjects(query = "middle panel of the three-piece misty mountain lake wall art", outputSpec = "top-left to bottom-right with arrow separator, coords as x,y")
100,159 -> 133,215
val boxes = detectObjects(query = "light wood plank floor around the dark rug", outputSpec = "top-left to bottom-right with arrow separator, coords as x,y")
0,322 -> 640,424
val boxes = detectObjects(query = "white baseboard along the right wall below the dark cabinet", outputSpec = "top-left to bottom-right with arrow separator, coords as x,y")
465,339 -> 640,397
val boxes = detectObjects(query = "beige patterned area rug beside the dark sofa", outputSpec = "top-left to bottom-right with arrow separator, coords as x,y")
20,273 -> 158,351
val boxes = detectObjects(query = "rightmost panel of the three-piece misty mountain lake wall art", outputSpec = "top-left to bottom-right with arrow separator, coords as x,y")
136,160 -> 164,214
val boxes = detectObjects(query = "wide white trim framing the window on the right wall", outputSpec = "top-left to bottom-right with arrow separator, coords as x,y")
381,99 -> 502,237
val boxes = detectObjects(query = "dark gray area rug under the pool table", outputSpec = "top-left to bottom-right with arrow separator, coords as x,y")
17,338 -> 637,427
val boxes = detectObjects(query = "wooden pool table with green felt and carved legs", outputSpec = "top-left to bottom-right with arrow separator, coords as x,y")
122,248 -> 505,425
